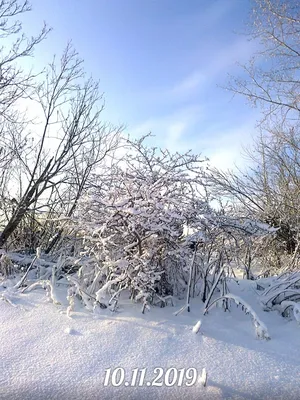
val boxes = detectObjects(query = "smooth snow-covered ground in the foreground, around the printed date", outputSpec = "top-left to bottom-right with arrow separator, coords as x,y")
0,281 -> 300,400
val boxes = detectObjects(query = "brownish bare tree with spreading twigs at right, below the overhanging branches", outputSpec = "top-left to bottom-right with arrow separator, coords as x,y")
205,130 -> 300,270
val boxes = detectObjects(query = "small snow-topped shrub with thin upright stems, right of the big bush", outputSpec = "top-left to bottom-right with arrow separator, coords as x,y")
188,212 -> 272,310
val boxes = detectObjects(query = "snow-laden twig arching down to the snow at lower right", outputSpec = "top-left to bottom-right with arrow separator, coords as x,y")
204,293 -> 271,340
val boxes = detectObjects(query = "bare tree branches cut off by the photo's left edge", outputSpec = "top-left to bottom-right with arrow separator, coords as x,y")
0,0 -> 49,241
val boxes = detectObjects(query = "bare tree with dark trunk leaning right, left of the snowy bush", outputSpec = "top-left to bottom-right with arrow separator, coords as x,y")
0,45 -> 120,246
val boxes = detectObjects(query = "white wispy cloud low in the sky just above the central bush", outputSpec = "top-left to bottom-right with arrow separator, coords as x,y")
131,105 -> 255,170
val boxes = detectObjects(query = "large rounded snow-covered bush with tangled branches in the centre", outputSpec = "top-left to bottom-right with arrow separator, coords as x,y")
65,141 -> 210,309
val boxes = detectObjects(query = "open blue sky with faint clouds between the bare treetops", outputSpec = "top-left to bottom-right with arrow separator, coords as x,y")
19,0 -> 257,168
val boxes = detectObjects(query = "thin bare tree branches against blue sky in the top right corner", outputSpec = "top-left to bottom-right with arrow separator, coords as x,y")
229,0 -> 300,120
